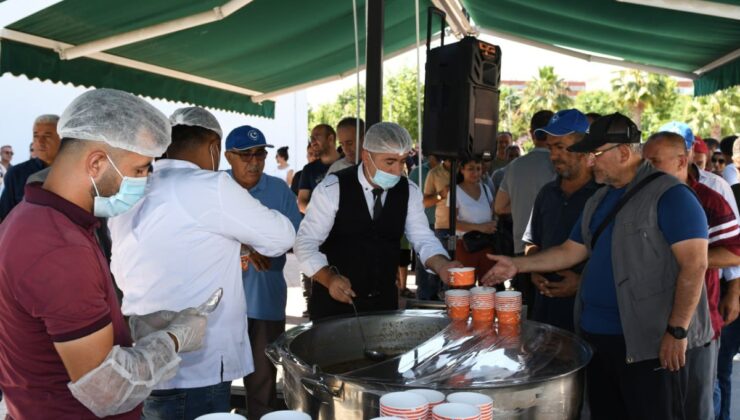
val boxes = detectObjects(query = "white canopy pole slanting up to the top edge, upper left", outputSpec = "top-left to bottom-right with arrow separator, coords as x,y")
59,0 -> 253,60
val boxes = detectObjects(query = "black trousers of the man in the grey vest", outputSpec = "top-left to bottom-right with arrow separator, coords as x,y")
582,332 -> 694,420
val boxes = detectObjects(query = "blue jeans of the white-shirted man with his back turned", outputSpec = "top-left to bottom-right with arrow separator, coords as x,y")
141,382 -> 231,420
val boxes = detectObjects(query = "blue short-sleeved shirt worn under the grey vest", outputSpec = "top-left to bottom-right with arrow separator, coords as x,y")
570,185 -> 707,335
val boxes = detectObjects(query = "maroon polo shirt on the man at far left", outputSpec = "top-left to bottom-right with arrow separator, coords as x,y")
0,184 -> 141,419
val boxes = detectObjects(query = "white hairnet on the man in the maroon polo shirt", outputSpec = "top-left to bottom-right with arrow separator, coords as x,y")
57,89 -> 172,157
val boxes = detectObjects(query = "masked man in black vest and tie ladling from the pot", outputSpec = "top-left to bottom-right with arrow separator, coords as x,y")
293,123 -> 461,320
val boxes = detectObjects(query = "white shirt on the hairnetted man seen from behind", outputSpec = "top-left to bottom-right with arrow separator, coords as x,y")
108,159 -> 295,389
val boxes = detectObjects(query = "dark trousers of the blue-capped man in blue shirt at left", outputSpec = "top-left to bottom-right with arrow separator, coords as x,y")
244,318 -> 285,419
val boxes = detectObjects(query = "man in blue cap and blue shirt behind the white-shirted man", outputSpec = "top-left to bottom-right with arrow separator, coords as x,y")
226,125 -> 301,419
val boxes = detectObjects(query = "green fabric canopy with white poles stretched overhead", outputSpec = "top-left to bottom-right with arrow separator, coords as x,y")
0,0 -> 740,117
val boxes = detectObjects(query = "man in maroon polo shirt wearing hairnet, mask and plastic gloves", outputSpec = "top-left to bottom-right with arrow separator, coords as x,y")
0,89 -> 211,420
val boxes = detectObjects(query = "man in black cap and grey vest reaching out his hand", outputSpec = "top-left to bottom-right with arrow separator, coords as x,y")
483,113 -> 712,419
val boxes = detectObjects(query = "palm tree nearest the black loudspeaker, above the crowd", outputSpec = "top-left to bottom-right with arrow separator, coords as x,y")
522,66 -> 573,115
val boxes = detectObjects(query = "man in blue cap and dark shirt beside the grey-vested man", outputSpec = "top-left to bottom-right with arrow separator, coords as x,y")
523,109 -> 598,331
